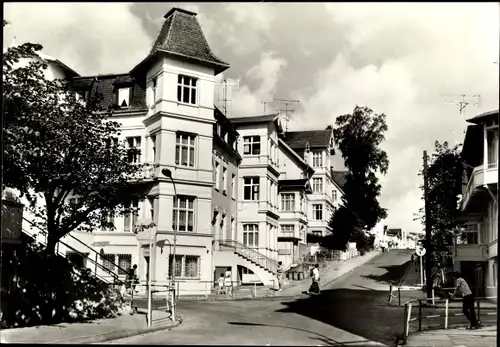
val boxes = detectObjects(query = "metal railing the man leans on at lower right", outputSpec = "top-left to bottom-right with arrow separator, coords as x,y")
403,287 -> 497,343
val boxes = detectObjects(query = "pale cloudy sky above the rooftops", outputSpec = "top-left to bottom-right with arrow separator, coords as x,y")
4,2 -> 500,237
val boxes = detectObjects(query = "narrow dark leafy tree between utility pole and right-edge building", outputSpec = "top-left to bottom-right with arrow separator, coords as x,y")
416,141 -> 463,264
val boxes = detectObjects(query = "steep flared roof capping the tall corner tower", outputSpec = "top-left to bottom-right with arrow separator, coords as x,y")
133,7 -> 229,75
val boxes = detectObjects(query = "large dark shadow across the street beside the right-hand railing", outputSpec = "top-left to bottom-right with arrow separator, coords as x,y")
278,289 -> 404,345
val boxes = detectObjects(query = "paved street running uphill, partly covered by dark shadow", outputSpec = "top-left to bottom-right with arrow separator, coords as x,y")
104,251 -> 410,346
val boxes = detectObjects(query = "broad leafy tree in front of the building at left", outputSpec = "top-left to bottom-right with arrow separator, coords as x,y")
2,35 -> 144,253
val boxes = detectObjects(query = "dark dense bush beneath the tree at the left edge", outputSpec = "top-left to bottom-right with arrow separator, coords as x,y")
2,240 -> 129,328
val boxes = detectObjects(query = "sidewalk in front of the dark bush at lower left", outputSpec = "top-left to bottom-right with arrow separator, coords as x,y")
0,310 -> 182,344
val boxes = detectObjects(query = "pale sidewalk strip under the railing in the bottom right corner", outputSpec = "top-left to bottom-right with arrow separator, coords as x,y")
405,325 -> 497,347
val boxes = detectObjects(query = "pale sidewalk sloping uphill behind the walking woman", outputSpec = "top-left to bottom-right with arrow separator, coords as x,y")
276,251 -> 382,296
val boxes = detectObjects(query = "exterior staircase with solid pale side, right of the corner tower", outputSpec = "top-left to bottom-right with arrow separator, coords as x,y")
217,240 -> 278,285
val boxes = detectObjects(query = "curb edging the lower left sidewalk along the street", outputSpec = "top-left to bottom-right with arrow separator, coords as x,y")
47,316 -> 184,344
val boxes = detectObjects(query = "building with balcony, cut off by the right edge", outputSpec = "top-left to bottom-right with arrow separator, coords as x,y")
453,110 -> 499,300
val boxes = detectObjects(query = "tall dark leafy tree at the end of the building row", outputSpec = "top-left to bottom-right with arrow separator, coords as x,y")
324,106 -> 389,249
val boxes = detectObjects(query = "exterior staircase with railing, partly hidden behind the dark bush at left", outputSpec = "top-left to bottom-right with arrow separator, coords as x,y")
22,217 -> 126,286
